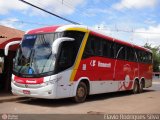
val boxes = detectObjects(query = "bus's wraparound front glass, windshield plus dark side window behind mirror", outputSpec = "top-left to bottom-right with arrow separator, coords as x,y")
13,31 -> 84,77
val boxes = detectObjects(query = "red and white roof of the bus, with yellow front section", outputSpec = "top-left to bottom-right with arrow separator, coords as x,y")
26,25 -> 151,52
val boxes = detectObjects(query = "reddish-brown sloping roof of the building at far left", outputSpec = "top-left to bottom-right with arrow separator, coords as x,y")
0,25 -> 24,49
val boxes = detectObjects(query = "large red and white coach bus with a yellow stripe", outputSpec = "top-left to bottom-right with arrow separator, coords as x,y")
5,25 -> 153,103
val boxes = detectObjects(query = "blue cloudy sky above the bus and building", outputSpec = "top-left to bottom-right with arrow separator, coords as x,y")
0,0 -> 160,46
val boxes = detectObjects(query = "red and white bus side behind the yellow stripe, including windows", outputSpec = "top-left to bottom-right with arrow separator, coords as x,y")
75,31 -> 152,94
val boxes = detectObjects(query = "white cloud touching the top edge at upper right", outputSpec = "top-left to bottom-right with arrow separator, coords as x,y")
113,0 -> 158,10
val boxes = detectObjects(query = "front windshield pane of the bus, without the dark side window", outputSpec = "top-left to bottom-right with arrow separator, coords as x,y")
13,33 -> 62,75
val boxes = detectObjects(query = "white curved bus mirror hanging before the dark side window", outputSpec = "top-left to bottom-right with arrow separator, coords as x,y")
52,37 -> 75,54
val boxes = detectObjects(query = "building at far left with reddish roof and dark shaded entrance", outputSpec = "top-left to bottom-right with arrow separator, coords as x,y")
0,25 -> 24,92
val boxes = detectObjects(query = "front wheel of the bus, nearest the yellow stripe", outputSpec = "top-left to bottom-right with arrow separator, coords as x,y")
74,82 -> 88,103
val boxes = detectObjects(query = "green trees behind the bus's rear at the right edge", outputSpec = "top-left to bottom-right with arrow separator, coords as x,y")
144,43 -> 160,72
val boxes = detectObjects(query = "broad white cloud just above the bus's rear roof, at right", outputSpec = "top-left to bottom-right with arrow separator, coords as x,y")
92,22 -> 160,46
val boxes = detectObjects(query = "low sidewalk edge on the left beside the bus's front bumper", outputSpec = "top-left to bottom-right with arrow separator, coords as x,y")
0,92 -> 26,103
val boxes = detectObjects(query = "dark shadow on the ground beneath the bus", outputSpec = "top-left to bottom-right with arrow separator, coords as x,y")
17,90 -> 154,107
